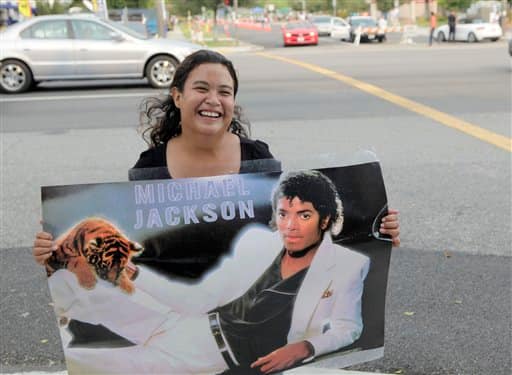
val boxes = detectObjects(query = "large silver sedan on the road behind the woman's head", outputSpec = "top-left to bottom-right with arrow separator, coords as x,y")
0,15 -> 202,93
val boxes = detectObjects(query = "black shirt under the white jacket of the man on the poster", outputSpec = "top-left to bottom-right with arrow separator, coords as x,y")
213,252 -> 308,367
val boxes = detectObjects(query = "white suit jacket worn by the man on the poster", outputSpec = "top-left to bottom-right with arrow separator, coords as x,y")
49,225 -> 370,356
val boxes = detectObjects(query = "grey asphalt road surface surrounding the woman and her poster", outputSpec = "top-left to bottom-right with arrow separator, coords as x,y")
0,36 -> 512,374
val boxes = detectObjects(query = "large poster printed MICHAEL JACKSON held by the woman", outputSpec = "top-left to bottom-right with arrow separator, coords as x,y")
42,162 -> 391,374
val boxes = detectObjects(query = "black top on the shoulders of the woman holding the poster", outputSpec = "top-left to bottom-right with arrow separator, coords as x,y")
128,137 -> 281,181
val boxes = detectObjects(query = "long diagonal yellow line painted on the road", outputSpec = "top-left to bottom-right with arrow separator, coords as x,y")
257,52 -> 512,152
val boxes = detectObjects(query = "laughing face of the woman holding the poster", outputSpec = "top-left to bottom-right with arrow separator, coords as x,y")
171,63 -> 235,139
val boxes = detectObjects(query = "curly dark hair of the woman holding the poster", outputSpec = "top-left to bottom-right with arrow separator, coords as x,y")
139,49 -> 250,148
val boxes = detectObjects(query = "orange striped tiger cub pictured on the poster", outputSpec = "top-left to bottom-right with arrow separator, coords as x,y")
45,217 -> 144,294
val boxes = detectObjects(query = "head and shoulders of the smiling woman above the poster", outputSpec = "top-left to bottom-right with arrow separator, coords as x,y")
130,50 -> 279,178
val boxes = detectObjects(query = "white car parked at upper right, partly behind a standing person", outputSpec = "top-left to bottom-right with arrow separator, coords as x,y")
434,18 -> 503,43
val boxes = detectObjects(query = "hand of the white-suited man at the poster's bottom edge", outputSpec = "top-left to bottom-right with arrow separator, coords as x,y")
251,341 -> 312,374
